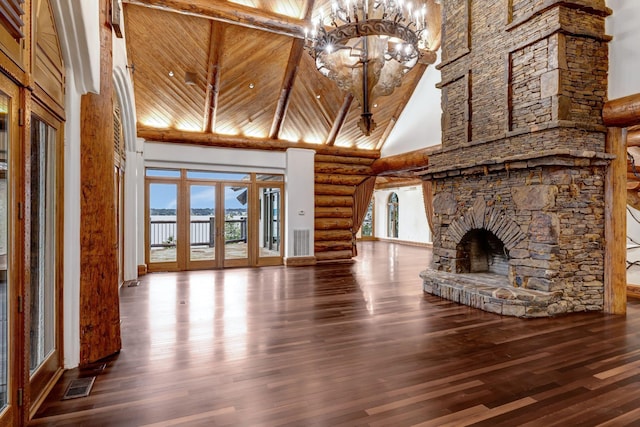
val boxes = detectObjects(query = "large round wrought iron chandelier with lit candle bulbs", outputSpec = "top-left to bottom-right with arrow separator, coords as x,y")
305,0 -> 440,136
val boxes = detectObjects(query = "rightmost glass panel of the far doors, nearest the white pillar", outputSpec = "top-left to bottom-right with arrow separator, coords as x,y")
258,187 -> 282,258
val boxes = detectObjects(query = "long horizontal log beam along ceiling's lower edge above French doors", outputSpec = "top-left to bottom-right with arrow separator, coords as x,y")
138,129 -> 380,159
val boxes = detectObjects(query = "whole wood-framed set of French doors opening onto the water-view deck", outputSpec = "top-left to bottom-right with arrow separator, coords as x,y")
146,169 -> 283,271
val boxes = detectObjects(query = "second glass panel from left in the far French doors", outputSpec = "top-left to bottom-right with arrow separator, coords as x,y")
189,184 -> 217,262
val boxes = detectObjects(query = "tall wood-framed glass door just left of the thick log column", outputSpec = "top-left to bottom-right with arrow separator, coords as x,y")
28,104 -> 62,418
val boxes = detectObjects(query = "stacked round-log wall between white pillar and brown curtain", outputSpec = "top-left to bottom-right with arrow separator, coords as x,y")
314,154 -> 375,261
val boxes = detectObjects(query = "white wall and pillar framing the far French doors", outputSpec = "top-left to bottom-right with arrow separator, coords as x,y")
138,142 -> 315,257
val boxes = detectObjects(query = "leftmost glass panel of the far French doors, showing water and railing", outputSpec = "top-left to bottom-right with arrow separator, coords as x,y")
147,182 -> 178,264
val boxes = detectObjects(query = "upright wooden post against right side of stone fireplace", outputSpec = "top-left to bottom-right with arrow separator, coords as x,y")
604,127 -> 627,314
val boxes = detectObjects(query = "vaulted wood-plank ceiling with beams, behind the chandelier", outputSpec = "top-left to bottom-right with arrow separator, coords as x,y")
124,0 -> 441,150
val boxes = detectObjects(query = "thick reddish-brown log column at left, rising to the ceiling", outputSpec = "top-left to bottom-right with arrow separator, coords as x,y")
80,0 -> 121,365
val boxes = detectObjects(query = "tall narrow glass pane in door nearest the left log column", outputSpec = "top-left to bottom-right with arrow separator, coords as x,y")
30,117 -> 57,373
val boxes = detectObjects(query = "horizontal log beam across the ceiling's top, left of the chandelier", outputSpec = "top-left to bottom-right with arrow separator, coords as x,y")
123,0 -> 308,39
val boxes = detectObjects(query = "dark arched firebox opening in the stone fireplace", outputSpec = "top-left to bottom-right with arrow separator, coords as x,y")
456,228 -> 509,276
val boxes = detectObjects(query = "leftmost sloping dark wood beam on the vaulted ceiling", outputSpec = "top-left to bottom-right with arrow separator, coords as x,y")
204,22 -> 224,133
